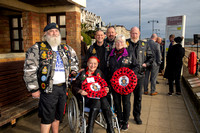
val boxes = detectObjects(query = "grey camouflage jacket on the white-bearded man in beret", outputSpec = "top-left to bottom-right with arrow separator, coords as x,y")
24,42 -> 79,93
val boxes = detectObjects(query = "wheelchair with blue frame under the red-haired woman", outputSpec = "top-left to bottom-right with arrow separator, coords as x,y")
66,87 -> 120,133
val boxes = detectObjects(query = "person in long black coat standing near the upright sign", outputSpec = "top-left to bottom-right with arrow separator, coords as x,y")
164,37 -> 185,96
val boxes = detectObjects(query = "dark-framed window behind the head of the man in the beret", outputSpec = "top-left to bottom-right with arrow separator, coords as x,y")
47,13 -> 66,43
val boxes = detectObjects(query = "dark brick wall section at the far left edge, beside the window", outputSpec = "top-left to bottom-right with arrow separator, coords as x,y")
0,16 -> 11,53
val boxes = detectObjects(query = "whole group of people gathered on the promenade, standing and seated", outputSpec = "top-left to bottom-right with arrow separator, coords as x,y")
24,23 -> 183,133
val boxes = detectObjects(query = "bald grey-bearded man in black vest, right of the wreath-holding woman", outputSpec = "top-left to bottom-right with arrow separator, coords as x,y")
126,27 -> 153,124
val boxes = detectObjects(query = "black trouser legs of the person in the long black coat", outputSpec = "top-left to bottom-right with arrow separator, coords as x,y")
168,77 -> 181,93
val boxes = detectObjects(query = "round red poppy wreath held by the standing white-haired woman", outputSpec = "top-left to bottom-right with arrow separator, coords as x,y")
110,67 -> 137,95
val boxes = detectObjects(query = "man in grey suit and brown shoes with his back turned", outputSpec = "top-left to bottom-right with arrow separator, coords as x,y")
144,34 -> 161,96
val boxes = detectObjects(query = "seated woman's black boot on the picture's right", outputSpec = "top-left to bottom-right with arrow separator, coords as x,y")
102,109 -> 115,133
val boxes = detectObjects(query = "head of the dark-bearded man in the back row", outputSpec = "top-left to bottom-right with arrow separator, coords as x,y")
105,26 -> 117,50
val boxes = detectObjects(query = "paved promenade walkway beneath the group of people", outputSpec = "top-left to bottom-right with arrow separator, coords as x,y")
0,76 -> 200,133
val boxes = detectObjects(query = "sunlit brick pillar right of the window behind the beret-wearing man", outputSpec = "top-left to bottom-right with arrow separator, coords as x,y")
66,12 -> 81,64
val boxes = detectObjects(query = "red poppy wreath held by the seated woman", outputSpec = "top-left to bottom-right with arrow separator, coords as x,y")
81,76 -> 108,98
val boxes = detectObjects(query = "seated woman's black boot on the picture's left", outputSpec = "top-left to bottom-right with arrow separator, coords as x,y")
86,108 -> 99,133
